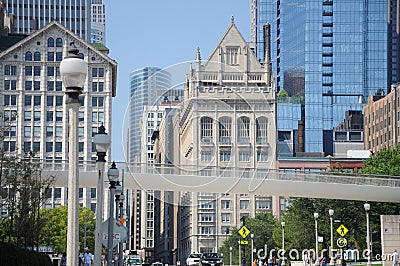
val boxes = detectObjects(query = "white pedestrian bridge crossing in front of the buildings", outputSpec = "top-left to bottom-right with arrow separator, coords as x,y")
43,163 -> 400,203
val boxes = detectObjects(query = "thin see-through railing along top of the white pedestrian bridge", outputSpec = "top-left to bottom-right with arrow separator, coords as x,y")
42,161 -> 400,187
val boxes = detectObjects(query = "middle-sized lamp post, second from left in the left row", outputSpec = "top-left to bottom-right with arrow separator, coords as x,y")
93,125 -> 111,265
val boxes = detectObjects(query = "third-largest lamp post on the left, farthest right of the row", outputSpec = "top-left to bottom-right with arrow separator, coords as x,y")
107,162 -> 119,265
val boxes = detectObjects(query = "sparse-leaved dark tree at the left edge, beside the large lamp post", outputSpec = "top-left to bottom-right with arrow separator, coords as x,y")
0,111 -> 54,248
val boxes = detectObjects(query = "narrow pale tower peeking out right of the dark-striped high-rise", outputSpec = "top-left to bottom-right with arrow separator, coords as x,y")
90,0 -> 106,43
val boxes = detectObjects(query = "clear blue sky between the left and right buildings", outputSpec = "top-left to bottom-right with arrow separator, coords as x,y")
105,0 -> 250,161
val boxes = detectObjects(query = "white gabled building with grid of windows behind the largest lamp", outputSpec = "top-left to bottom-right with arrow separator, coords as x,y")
0,22 -> 117,211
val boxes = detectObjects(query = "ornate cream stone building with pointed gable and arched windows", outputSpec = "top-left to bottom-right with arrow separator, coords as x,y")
177,18 -> 276,258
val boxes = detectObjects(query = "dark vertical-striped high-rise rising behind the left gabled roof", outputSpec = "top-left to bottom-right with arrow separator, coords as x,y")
4,0 -> 91,42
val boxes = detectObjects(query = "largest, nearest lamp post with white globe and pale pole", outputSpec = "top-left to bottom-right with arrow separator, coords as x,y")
60,43 -> 87,265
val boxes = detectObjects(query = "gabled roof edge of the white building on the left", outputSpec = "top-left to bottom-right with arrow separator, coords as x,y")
0,21 -> 117,97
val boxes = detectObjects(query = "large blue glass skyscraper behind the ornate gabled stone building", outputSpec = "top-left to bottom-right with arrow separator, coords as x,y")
251,0 -> 388,155
